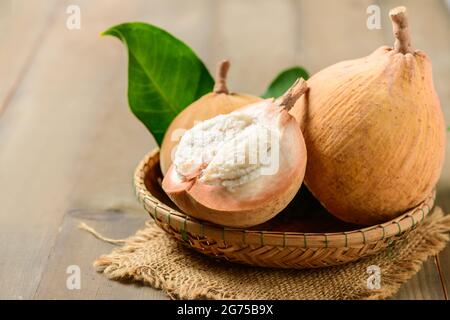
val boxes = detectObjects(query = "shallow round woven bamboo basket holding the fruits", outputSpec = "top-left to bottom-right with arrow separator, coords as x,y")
134,149 -> 435,269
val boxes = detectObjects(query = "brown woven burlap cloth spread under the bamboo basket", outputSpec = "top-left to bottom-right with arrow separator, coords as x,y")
91,208 -> 450,299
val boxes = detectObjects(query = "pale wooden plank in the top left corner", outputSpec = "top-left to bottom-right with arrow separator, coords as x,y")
0,0 -> 56,115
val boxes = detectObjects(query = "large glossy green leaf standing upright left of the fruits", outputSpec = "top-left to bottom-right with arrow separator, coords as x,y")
103,22 -> 214,144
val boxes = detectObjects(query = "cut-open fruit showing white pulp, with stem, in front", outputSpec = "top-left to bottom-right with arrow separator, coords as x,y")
162,79 -> 307,227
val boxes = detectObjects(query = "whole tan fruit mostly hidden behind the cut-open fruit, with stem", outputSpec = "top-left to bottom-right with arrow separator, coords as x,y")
160,60 -> 261,174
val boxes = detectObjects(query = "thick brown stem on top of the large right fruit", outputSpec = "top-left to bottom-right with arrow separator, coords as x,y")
389,7 -> 413,54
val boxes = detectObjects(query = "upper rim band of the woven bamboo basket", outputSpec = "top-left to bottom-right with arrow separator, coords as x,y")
134,148 -> 436,248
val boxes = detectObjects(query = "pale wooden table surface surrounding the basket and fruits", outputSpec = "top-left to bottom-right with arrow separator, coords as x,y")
0,0 -> 450,299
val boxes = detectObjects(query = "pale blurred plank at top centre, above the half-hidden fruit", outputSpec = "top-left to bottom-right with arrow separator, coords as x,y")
213,0 -> 296,95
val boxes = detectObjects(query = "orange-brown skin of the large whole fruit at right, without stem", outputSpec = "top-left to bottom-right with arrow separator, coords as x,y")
291,47 -> 445,225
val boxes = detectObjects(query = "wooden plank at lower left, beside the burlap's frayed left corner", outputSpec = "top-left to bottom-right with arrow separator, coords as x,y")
35,208 -> 166,299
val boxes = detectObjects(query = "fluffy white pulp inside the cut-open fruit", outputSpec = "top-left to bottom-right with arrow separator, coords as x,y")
173,112 -> 279,190
